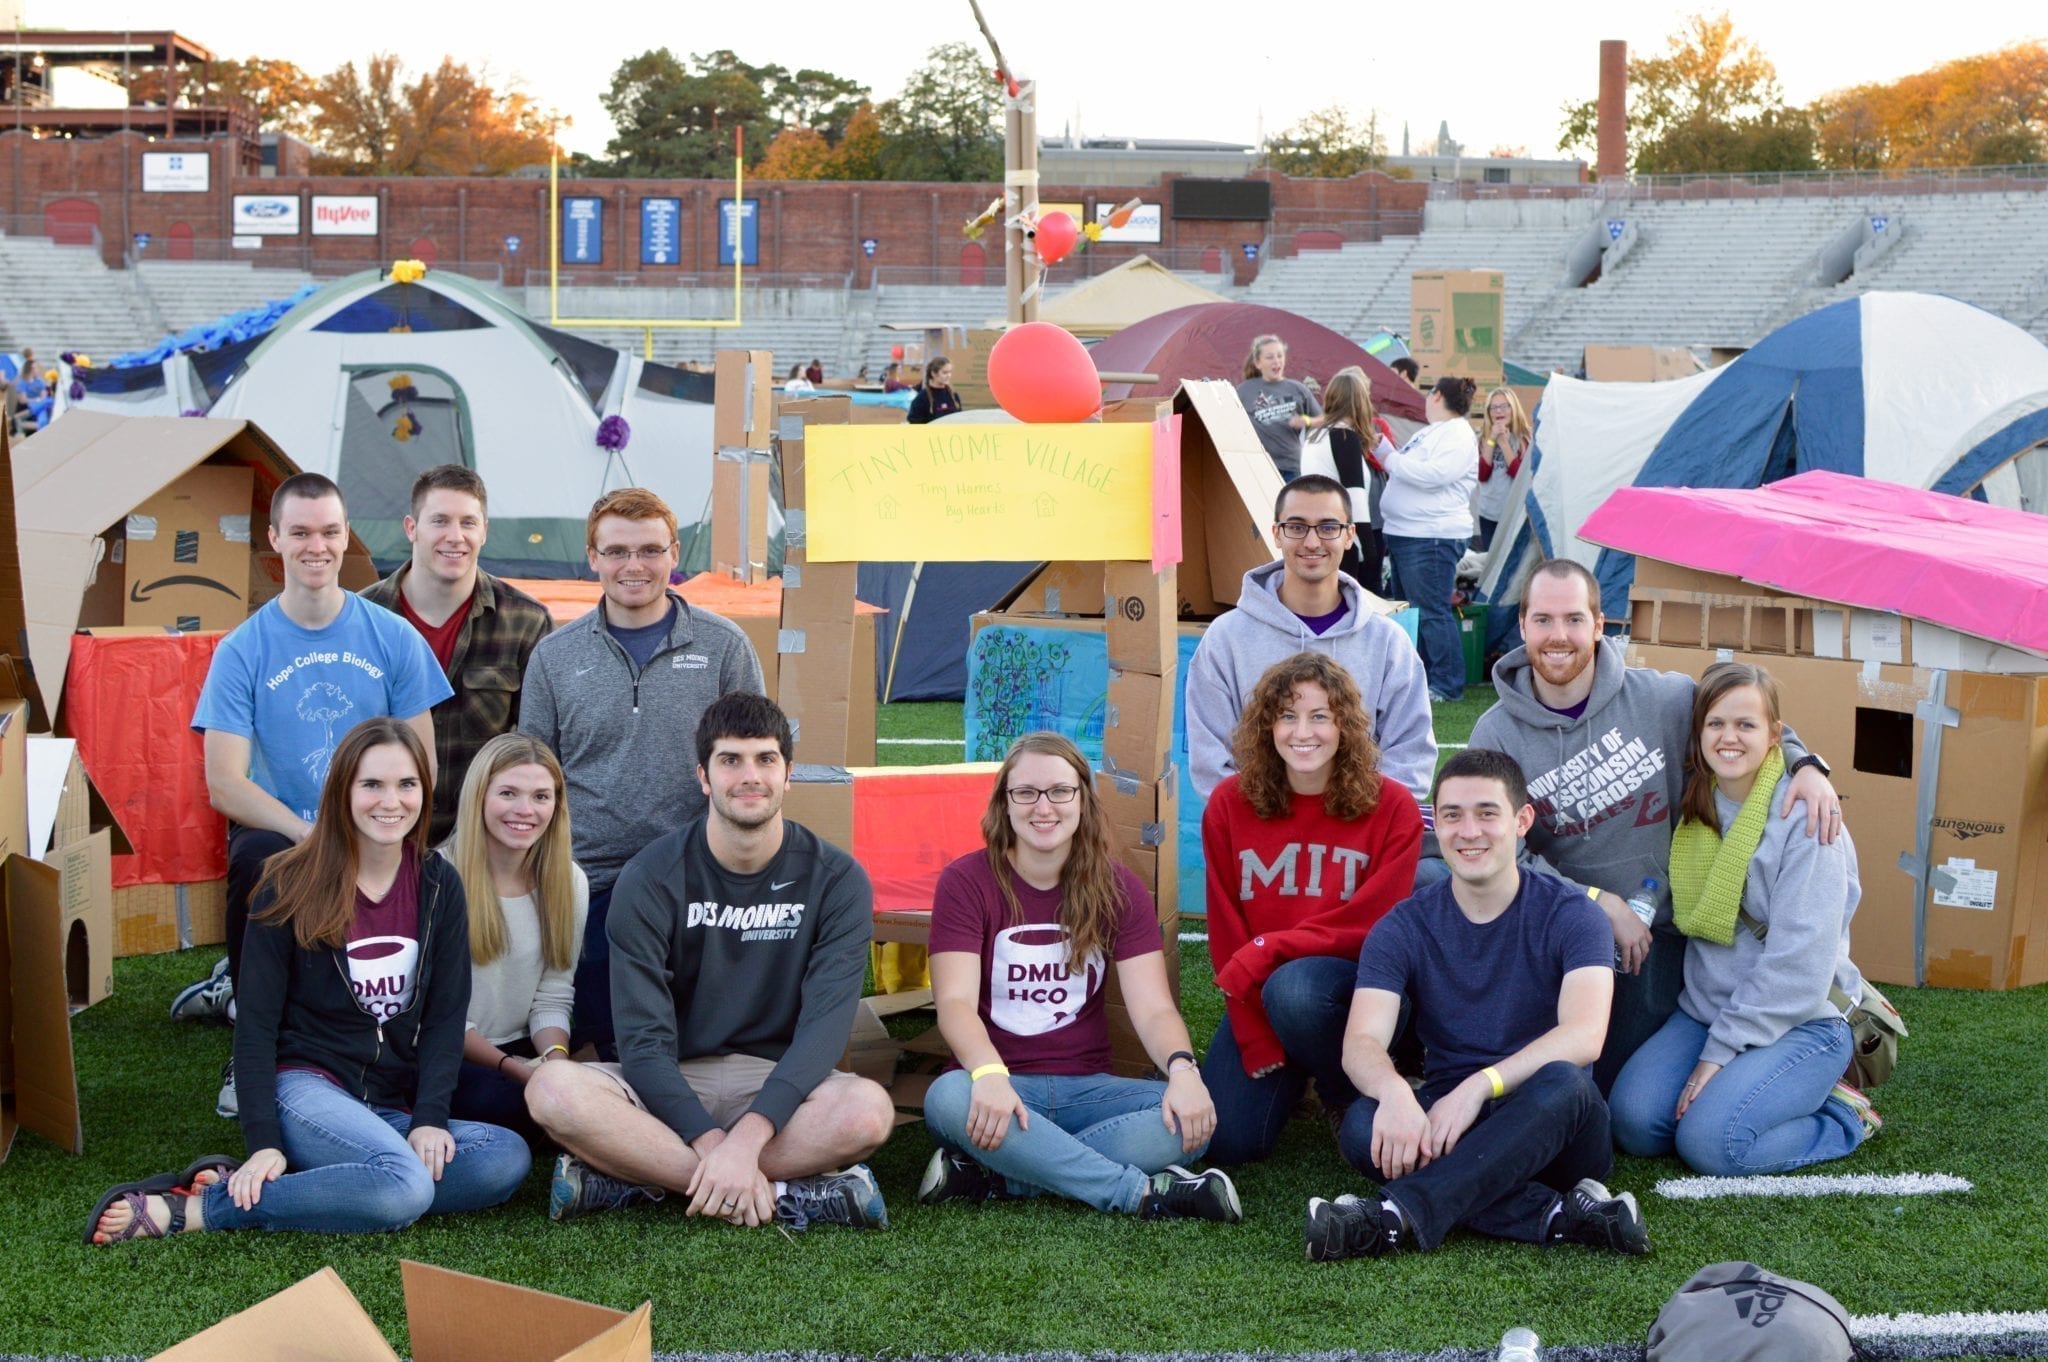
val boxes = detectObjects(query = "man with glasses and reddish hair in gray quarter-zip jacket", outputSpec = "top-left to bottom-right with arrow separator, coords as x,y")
518,487 -> 766,1059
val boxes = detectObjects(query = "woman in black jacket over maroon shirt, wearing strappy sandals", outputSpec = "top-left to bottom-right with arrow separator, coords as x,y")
86,719 -> 530,1243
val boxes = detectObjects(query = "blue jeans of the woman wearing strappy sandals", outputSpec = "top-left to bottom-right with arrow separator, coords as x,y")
203,1069 -> 532,1235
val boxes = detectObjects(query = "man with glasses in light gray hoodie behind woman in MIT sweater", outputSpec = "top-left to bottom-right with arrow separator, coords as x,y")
1186,473 -> 1442,811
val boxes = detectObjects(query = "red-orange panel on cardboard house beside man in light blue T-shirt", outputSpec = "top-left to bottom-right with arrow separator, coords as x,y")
63,633 -> 227,887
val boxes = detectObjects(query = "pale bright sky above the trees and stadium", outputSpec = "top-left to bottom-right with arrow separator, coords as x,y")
19,0 -> 2048,156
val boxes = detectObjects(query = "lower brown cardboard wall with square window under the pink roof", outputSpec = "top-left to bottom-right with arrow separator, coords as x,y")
1628,645 -> 2048,989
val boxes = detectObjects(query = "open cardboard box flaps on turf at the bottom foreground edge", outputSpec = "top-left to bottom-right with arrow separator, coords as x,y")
156,1260 -> 653,1362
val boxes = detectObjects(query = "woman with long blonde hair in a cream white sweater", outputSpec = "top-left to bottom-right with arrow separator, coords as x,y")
440,733 -> 590,1141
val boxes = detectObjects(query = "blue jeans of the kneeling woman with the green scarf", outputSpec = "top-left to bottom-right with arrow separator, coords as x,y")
1614,1012 -> 1864,1178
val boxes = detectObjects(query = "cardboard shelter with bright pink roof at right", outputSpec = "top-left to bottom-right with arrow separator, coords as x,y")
1583,473 -> 2048,989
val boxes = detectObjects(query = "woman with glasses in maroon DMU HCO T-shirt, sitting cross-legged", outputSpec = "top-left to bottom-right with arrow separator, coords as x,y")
918,733 -> 1241,1221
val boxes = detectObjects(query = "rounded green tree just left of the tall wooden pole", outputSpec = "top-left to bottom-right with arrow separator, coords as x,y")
874,43 -> 1004,182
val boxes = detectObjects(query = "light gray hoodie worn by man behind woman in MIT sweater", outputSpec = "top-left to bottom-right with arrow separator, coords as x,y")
1188,545 -> 1436,807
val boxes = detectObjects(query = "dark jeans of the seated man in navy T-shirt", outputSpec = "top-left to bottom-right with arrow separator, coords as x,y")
1337,1061 -> 1614,1249
